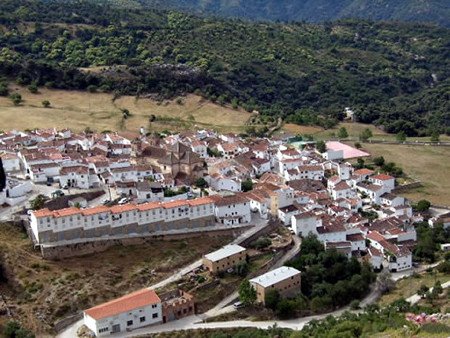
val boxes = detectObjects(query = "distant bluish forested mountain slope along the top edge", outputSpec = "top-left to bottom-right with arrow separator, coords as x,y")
108,0 -> 450,27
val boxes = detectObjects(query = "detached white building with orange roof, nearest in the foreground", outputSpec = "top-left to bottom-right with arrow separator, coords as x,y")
84,289 -> 162,337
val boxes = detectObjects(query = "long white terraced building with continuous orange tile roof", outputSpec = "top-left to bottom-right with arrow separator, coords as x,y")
30,197 -> 215,246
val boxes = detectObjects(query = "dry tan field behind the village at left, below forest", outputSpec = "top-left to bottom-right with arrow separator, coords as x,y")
0,85 -> 250,132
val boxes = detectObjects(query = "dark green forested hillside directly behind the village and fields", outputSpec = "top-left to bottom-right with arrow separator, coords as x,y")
0,0 -> 450,135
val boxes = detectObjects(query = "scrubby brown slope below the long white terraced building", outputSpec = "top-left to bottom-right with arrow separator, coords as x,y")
0,224 -> 231,334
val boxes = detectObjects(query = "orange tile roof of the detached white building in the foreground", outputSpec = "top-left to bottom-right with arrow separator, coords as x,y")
84,289 -> 161,320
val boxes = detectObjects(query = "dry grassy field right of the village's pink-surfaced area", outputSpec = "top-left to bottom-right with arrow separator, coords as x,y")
363,143 -> 450,206
